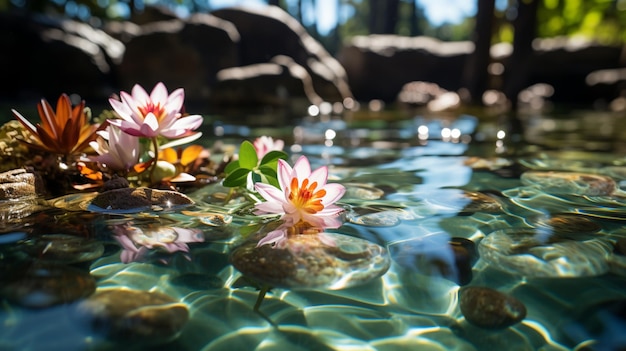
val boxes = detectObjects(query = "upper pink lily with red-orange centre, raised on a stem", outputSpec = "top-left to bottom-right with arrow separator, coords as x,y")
109,82 -> 202,138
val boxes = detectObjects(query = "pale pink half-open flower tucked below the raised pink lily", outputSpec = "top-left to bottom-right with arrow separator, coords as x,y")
89,126 -> 140,172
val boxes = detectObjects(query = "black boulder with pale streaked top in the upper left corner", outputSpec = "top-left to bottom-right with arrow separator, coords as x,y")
0,13 -> 124,101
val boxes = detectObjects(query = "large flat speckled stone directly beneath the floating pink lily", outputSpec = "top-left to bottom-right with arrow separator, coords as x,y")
230,233 -> 391,290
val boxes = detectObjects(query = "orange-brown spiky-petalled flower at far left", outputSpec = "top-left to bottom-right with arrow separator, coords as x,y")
11,94 -> 104,155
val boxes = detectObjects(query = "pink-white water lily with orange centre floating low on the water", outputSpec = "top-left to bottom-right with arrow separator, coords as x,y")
255,156 -> 346,245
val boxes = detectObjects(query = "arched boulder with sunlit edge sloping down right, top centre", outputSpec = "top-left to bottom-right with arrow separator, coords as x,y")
212,6 -> 352,102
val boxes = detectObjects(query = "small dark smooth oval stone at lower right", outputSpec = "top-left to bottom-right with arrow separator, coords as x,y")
459,286 -> 526,329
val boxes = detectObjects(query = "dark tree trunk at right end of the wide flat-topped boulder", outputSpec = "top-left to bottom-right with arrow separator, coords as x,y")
463,0 -> 495,104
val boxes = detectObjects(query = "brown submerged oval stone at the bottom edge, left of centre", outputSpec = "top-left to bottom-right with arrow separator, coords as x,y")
78,288 -> 189,344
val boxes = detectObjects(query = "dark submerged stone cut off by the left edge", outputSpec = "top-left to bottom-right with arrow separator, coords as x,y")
0,262 -> 96,308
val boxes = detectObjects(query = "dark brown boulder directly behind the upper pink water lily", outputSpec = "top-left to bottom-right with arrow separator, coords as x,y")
109,14 -> 239,104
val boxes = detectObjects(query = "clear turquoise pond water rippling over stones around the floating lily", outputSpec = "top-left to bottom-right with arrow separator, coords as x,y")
0,107 -> 626,351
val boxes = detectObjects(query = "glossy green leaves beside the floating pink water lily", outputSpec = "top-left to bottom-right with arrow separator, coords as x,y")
223,140 -> 287,188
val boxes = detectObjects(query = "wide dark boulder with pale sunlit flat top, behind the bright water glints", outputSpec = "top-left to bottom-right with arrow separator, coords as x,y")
338,35 -> 474,101
